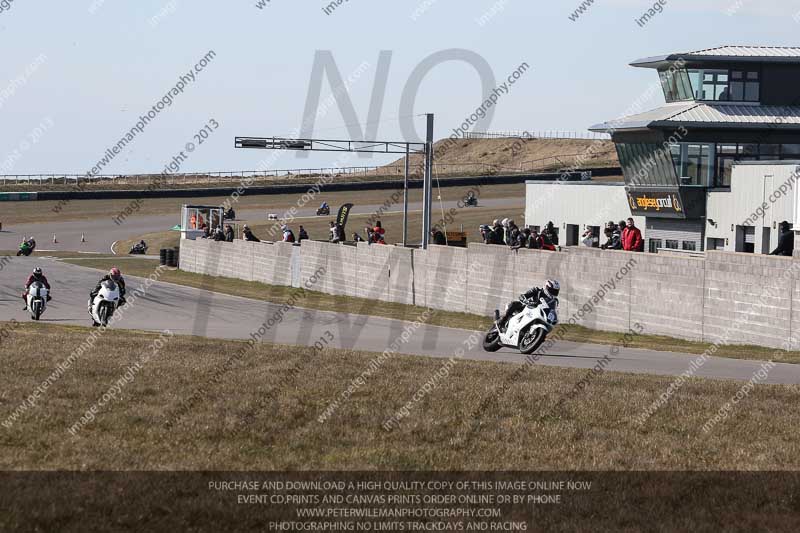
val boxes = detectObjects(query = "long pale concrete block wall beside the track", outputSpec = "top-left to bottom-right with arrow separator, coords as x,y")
180,240 -> 800,348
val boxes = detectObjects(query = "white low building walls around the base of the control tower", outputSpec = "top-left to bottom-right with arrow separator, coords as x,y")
525,160 -> 800,254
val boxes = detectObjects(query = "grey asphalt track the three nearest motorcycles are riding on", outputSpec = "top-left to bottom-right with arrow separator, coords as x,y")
0,257 -> 800,384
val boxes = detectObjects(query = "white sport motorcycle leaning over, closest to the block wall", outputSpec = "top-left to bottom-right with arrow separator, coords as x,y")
483,298 -> 558,355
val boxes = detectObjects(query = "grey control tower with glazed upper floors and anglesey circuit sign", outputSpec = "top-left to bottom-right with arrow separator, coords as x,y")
590,46 -> 800,253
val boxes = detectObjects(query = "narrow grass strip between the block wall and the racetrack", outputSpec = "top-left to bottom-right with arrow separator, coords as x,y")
64,257 -> 800,364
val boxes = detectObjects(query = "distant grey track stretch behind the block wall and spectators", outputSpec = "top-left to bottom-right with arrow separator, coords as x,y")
0,197 -> 525,254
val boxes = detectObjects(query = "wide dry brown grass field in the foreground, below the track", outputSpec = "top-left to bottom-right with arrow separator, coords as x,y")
0,318 -> 800,470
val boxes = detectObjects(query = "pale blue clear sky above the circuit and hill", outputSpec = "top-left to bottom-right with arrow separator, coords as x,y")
0,0 -> 800,174
